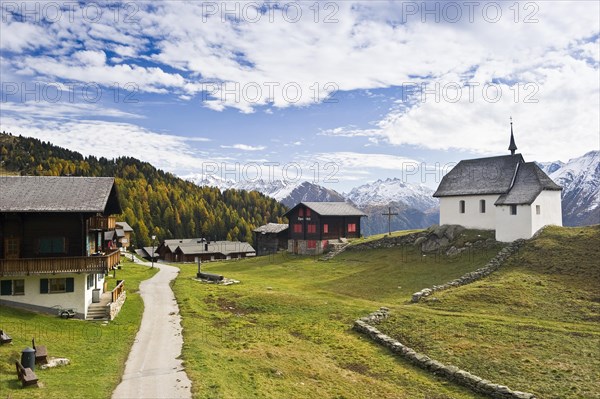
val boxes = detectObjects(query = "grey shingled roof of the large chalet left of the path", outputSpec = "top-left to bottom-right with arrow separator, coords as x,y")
0,176 -> 121,214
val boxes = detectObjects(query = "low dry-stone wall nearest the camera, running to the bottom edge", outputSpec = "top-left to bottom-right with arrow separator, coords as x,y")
353,307 -> 535,399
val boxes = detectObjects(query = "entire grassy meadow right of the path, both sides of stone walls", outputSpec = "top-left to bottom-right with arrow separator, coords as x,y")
174,227 -> 600,399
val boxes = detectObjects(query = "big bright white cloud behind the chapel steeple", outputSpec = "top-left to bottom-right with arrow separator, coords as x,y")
322,42 -> 600,161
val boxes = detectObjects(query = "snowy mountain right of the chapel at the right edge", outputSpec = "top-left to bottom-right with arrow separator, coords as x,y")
545,151 -> 600,226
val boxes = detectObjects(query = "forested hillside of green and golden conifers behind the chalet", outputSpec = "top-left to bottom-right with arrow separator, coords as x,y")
0,132 -> 286,248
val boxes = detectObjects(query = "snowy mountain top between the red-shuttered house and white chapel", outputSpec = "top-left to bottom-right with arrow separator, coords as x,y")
346,178 -> 439,211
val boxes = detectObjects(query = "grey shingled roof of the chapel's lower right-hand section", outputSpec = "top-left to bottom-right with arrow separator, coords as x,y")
495,162 -> 562,205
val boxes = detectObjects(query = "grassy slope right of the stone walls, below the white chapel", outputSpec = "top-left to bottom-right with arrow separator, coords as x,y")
380,226 -> 600,399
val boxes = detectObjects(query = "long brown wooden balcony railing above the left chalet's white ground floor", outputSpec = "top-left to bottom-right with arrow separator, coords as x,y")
0,250 -> 121,276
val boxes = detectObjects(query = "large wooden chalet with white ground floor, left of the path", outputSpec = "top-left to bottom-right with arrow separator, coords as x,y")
0,176 -> 125,319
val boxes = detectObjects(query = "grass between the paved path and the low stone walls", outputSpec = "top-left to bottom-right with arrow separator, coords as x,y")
173,233 -> 510,399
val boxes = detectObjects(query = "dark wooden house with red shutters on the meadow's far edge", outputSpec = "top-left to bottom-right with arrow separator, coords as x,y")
284,202 -> 366,255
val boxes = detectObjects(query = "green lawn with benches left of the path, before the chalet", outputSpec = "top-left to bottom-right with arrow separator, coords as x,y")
0,262 -> 158,399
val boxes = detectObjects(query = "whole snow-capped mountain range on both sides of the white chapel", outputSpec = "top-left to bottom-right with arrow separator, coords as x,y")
184,151 -> 600,235
